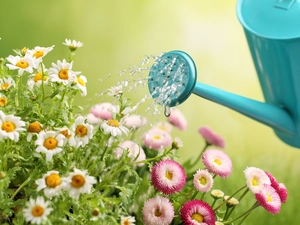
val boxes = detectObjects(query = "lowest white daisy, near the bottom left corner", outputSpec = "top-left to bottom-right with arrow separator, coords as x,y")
23,196 -> 53,224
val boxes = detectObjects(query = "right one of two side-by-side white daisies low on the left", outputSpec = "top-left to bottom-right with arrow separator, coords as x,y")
64,168 -> 96,199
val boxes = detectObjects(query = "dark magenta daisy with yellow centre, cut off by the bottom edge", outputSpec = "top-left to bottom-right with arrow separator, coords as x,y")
180,199 -> 216,225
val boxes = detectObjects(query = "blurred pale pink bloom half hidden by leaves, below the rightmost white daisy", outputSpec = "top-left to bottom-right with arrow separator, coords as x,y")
115,140 -> 146,166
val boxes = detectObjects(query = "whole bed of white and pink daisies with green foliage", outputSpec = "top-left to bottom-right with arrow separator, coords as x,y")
0,40 -> 287,225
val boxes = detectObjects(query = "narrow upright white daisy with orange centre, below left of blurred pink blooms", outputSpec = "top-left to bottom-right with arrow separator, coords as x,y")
71,116 -> 94,148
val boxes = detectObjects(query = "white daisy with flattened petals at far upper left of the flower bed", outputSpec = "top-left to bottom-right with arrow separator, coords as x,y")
6,55 -> 35,76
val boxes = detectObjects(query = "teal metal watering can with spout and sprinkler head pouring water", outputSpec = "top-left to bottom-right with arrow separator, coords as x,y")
148,0 -> 300,148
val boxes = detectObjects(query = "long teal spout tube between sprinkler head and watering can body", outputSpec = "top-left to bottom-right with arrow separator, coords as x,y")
192,82 -> 296,135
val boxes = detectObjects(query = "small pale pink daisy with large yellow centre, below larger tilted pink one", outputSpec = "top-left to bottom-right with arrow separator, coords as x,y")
193,170 -> 214,192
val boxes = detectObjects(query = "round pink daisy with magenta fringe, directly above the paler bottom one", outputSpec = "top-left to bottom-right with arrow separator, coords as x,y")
151,159 -> 186,195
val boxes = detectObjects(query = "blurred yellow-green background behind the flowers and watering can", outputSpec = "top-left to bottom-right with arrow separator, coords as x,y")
0,0 -> 300,225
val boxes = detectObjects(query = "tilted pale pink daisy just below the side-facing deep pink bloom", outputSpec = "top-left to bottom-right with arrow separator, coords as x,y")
202,149 -> 232,178
